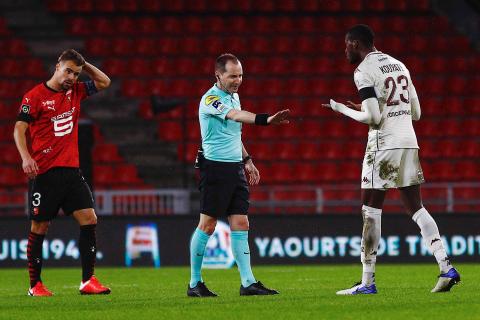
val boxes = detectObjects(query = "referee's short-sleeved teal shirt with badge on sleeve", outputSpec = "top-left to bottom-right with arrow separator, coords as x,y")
198,85 -> 242,162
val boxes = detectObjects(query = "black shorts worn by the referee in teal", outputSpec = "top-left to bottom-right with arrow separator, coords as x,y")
199,159 -> 250,218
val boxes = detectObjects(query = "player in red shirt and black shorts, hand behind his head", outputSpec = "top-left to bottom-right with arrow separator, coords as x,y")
14,49 -> 110,296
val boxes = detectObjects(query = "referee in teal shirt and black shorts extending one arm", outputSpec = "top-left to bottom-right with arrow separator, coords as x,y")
187,53 -> 290,297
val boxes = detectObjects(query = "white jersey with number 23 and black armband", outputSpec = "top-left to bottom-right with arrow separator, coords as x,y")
354,51 -> 418,152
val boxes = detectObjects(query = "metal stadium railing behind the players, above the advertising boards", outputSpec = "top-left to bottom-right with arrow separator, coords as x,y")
0,182 -> 480,216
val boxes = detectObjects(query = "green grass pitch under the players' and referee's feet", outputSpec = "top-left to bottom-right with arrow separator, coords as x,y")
0,263 -> 480,320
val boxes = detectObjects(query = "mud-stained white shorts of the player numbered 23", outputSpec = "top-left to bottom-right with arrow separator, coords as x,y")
362,149 -> 425,190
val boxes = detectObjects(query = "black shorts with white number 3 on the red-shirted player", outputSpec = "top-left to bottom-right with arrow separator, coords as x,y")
28,167 -> 94,221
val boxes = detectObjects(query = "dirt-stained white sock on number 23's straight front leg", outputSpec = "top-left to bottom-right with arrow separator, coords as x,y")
360,206 -> 382,286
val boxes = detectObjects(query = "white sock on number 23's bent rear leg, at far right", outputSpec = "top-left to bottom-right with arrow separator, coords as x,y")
412,208 -> 452,273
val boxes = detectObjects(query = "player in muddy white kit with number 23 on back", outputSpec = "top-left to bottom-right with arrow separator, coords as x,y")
324,25 -> 460,295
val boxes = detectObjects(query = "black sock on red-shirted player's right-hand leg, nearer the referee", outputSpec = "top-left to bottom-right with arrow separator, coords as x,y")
78,224 -> 97,282
